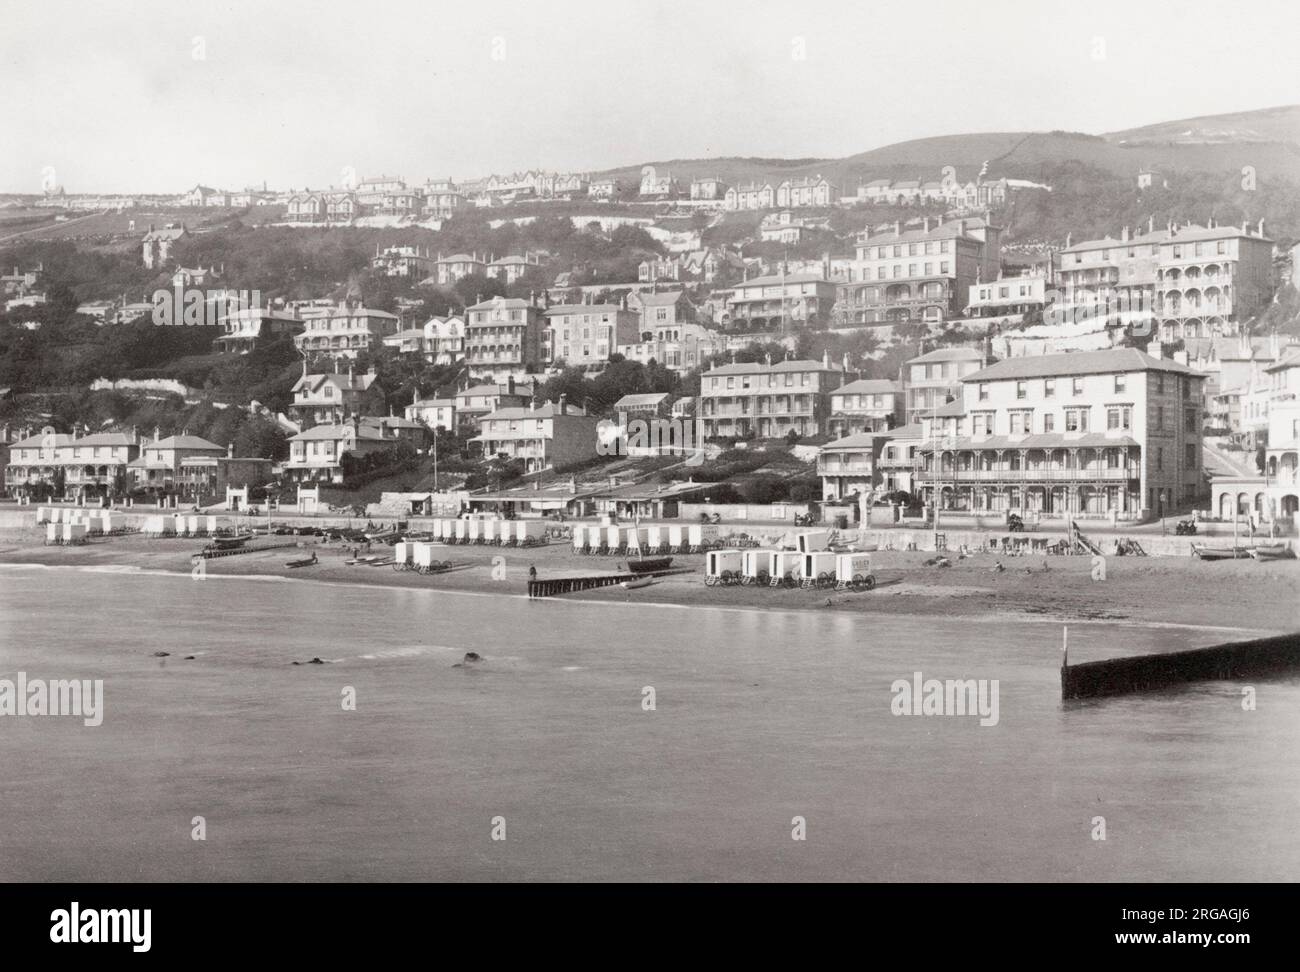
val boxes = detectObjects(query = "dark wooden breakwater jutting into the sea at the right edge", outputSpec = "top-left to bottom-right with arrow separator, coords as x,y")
1061,633 -> 1300,699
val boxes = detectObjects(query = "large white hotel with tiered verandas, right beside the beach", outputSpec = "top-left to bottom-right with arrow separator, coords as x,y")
917,348 -> 1206,520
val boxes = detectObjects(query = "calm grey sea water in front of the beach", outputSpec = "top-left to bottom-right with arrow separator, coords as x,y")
0,568 -> 1300,881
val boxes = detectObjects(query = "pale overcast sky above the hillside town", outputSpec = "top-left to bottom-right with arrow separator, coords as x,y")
0,0 -> 1300,192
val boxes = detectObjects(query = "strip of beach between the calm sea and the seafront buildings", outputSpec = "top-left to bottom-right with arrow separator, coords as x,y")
0,529 -> 1300,632
